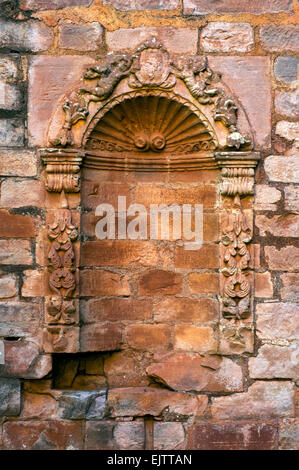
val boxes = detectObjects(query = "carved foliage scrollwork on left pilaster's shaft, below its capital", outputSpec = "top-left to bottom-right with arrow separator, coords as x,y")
46,189 -> 78,325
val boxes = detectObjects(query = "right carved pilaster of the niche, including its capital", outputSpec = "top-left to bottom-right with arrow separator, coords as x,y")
216,153 -> 259,354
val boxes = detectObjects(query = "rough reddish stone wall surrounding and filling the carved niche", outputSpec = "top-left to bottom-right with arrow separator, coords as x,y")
0,0 -> 299,450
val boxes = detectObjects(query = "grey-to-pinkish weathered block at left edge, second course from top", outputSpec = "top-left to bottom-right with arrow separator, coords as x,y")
0,19 -> 54,52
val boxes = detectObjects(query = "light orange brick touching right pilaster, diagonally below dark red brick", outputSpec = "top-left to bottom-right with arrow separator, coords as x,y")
154,297 -> 219,323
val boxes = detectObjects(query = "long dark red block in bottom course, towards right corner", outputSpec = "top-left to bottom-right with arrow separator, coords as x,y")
187,422 -> 278,450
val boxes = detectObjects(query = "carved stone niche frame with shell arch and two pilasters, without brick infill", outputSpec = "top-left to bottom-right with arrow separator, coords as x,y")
40,37 -> 259,354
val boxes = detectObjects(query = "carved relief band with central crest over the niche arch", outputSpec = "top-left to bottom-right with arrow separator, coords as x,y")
51,37 -> 250,149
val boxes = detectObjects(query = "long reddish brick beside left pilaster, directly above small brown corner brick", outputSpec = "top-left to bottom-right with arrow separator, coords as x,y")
82,298 -> 152,323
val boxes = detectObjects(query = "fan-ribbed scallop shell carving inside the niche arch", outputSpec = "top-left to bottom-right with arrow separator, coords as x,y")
86,95 -> 216,154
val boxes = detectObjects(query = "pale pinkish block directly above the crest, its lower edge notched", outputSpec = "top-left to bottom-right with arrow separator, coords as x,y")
106,26 -> 198,54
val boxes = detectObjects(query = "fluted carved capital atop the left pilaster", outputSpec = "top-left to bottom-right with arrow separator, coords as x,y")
40,149 -> 83,193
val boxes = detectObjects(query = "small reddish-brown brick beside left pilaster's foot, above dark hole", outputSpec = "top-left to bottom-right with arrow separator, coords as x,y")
80,323 -> 122,352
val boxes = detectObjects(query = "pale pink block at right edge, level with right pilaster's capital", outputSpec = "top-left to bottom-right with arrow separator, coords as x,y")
264,155 -> 299,183
